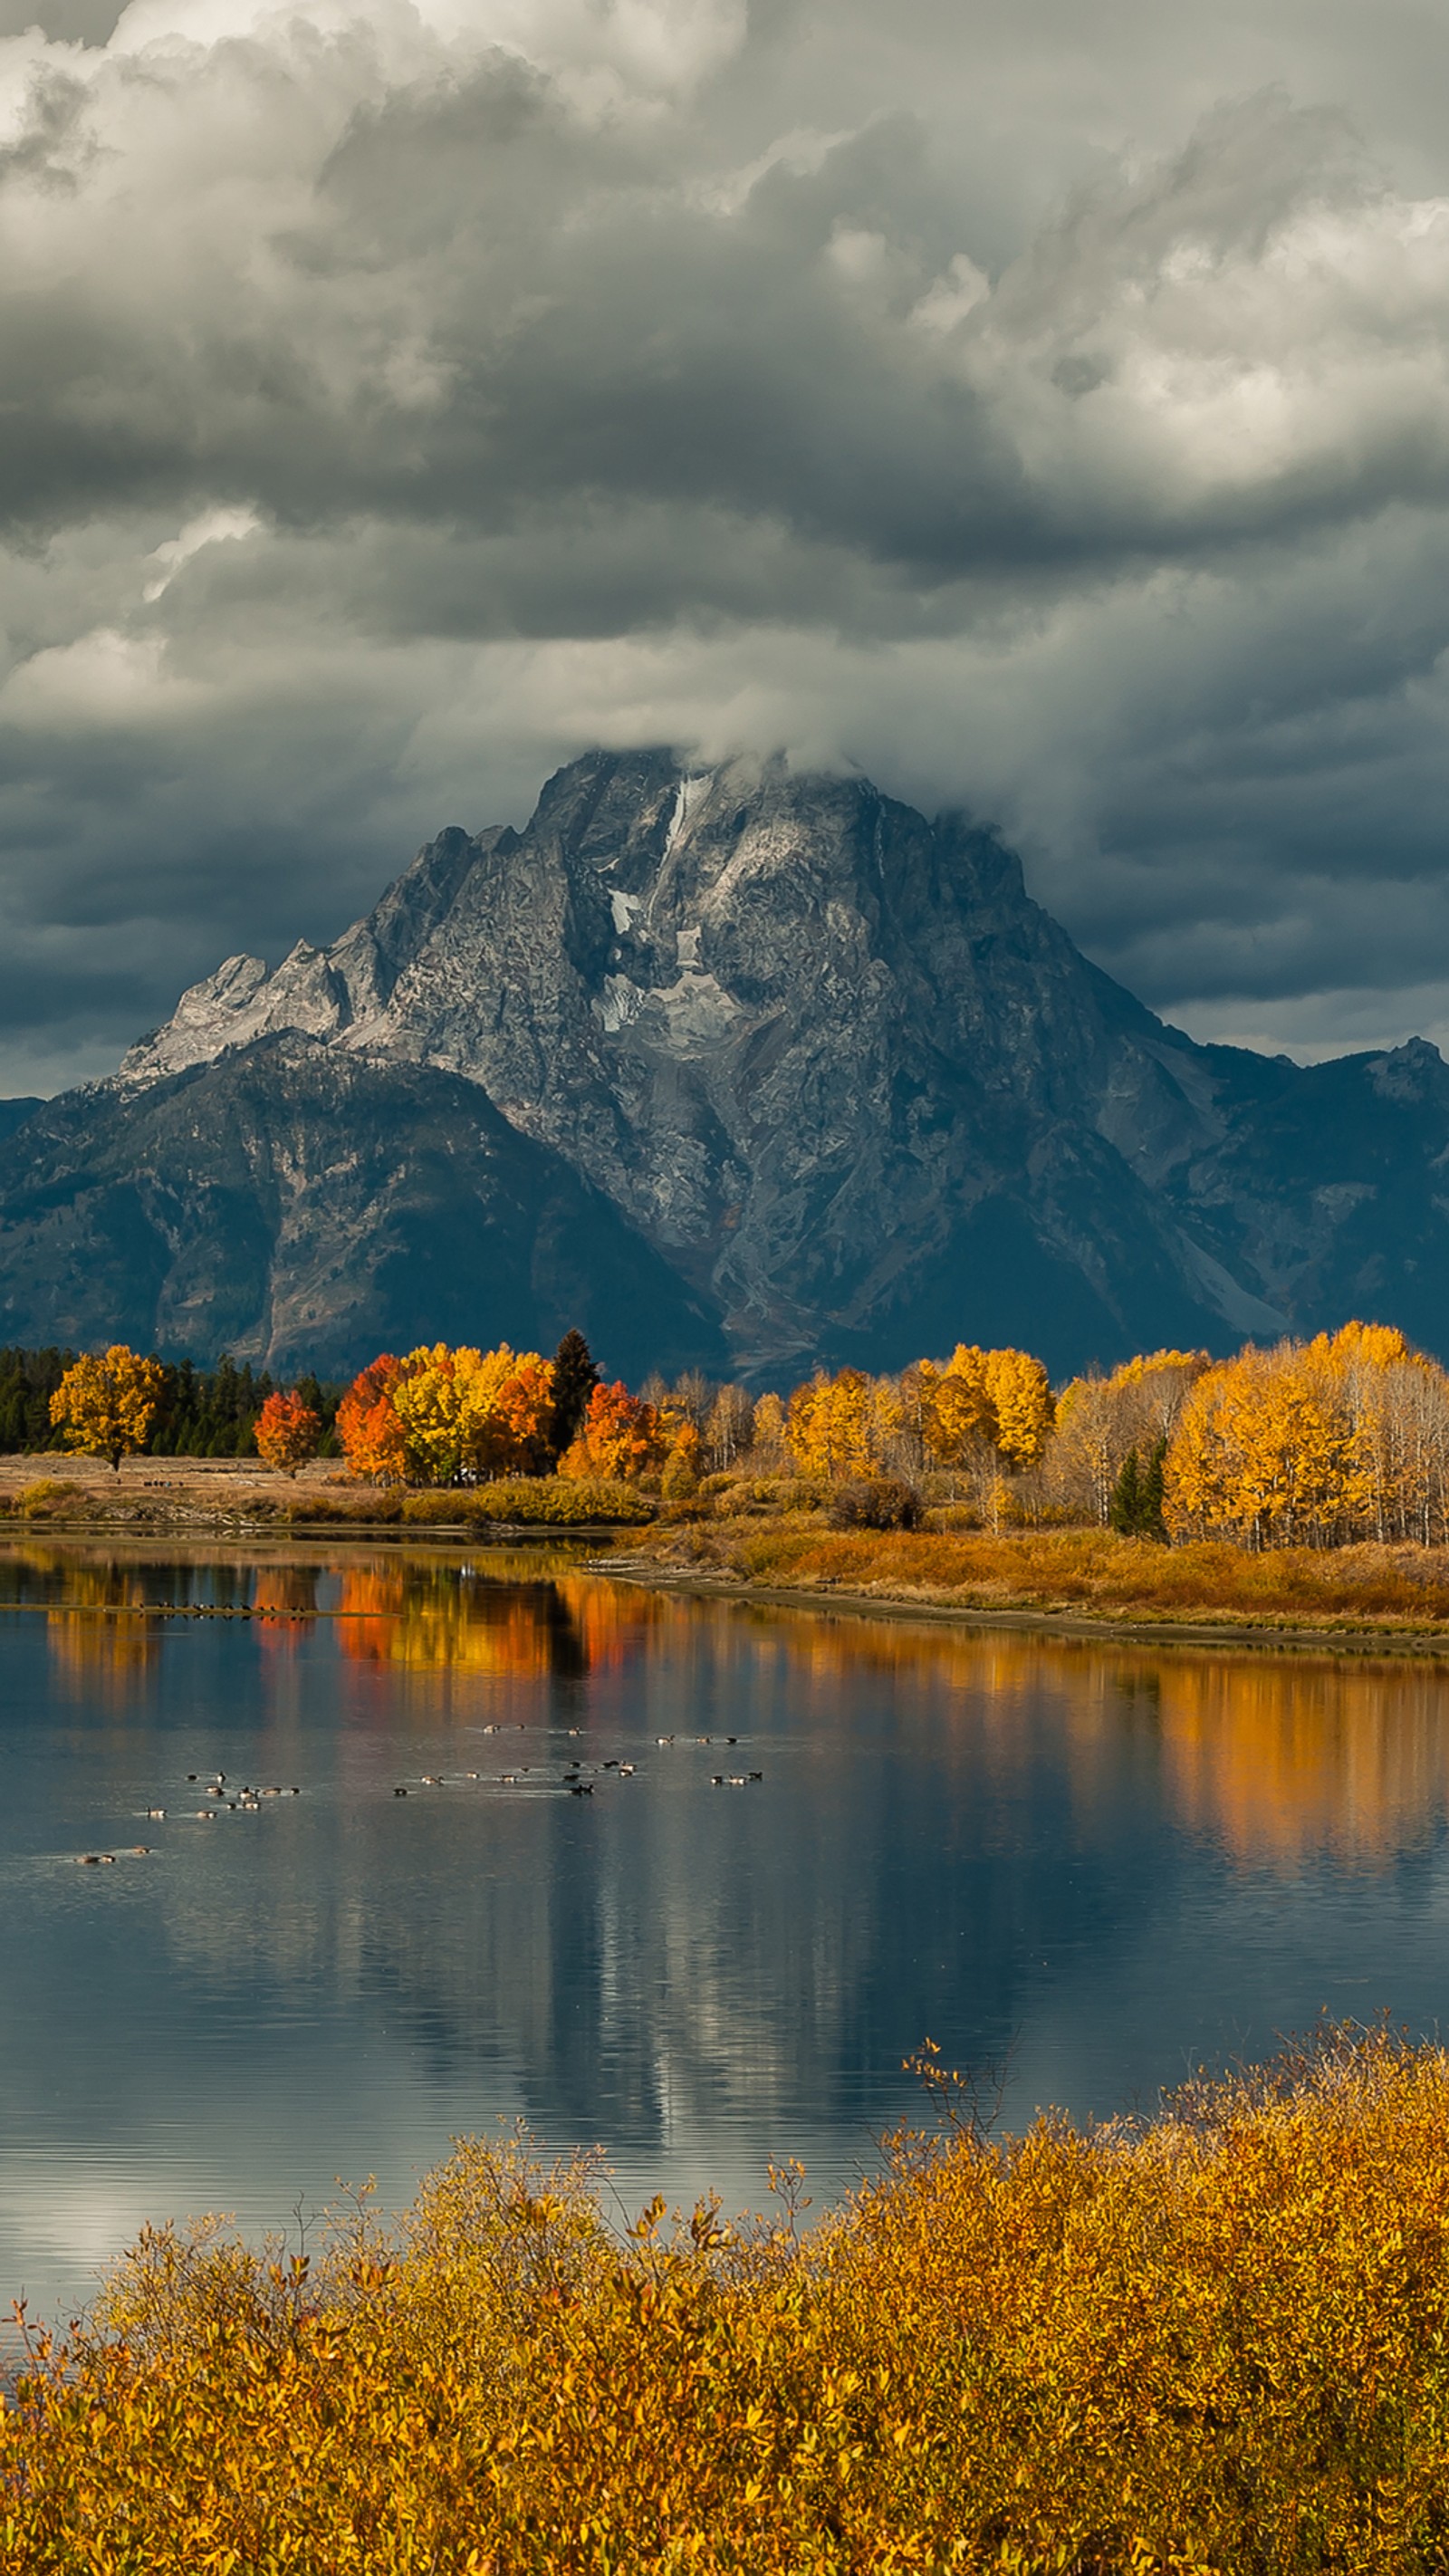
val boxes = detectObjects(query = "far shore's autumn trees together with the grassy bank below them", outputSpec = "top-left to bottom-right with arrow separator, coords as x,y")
11,1324 -> 1449,1651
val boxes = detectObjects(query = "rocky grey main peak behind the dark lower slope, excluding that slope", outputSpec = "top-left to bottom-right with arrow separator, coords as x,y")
16,752 -> 1449,1380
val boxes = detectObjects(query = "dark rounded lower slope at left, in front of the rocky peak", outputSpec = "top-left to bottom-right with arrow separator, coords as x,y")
0,1035 -> 724,1376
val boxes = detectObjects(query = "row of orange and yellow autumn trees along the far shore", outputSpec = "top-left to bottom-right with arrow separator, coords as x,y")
34,1322 -> 1449,1548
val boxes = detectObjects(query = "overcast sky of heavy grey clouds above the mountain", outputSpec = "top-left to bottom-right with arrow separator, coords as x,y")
0,0 -> 1449,1092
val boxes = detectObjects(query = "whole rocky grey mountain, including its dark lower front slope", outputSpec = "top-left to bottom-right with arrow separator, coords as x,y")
0,752 -> 1449,1383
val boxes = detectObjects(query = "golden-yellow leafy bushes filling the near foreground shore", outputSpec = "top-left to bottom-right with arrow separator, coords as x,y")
0,2030 -> 1449,2576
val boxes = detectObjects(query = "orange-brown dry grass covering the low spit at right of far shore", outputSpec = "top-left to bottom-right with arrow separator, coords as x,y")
618,1514 -> 1449,1628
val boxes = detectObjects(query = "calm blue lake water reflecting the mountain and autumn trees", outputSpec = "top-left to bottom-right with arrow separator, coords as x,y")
0,1543 -> 1449,2316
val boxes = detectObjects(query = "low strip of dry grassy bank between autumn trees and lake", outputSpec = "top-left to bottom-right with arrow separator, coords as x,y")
19,1456 -> 1449,1654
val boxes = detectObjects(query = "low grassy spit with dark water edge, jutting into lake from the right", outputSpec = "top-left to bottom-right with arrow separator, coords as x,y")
597,1514 -> 1449,1651
